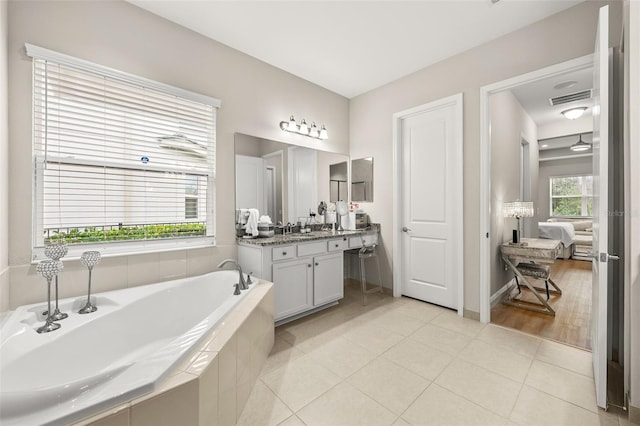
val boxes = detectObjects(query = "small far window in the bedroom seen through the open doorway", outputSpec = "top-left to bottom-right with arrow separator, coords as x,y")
549,175 -> 593,217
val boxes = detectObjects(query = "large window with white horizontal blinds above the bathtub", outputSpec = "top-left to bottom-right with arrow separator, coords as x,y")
27,45 -> 220,260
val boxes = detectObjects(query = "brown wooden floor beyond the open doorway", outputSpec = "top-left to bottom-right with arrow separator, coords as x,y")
491,260 -> 591,350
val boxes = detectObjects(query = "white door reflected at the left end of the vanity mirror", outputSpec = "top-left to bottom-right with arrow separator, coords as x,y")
236,155 -> 266,214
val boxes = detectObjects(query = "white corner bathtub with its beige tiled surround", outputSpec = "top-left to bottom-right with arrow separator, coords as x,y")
2,271 -> 273,425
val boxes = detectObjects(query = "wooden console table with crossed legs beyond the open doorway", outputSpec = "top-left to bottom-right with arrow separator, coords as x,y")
500,238 -> 562,316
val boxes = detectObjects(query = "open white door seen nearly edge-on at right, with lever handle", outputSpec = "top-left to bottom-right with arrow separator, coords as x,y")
591,6 -> 610,408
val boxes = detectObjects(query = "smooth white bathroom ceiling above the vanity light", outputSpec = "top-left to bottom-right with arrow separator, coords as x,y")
127,0 -> 584,98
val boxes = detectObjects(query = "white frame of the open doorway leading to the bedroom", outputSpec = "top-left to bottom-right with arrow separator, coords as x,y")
479,54 -> 593,324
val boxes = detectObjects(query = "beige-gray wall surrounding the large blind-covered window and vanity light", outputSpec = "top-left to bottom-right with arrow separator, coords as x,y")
0,1 -> 349,309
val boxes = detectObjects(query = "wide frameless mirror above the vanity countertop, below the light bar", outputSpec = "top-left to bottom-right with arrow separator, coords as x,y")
234,133 -> 349,224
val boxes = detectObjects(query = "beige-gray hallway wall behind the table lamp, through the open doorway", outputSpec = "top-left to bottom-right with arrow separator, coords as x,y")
489,91 -> 538,294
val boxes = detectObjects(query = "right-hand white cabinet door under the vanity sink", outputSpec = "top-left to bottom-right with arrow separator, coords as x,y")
313,252 -> 344,306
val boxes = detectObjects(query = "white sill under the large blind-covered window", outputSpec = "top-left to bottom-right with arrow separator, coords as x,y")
31,236 -> 216,264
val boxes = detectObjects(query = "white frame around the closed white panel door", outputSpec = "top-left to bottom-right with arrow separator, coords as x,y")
392,93 -> 464,316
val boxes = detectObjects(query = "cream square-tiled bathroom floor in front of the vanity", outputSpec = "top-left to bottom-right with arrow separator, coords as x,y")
238,286 -> 630,426
